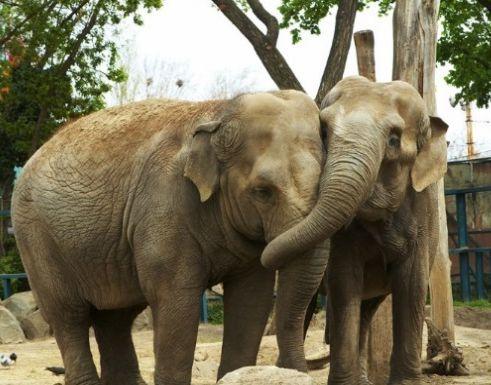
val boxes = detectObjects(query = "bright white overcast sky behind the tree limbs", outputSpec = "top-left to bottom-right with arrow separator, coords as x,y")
104,0 -> 491,159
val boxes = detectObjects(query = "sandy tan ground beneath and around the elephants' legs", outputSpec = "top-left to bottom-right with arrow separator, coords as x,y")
0,325 -> 491,385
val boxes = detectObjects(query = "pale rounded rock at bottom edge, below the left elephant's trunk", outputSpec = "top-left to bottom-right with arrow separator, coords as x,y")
217,366 -> 314,385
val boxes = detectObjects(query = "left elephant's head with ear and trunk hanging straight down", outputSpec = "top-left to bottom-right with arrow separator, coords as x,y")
185,91 -> 328,370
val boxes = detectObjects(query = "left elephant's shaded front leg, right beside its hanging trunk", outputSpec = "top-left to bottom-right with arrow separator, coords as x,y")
218,264 -> 275,379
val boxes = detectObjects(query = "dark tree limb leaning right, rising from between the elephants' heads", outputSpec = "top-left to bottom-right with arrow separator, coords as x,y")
315,0 -> 358,105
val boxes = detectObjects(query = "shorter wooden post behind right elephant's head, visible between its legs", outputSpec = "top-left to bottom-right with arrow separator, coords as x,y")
354,30 -> 392,384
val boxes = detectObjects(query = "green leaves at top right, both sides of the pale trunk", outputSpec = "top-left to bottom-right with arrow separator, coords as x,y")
279,0 -> 491,107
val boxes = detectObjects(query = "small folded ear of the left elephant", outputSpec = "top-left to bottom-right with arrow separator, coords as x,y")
184,121 -> 221,202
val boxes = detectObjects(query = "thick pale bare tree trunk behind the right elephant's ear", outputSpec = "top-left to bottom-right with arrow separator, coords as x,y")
393,0 -> 460,374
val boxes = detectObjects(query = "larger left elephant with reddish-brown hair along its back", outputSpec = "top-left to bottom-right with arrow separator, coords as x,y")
12,91 -> 327,385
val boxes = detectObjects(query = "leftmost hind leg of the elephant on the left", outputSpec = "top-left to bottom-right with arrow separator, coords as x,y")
14,226 -> 101,385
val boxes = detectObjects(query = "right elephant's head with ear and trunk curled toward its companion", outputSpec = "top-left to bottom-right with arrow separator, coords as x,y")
261,77 -> 447,266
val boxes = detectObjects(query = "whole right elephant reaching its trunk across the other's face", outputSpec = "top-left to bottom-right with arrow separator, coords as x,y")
262,77 -> 447,385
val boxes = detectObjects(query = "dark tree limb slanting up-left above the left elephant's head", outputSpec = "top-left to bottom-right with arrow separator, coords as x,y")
212,0 -> 303,91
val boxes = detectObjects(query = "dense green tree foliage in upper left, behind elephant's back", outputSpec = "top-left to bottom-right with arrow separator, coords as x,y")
0,0 -> 162,183
